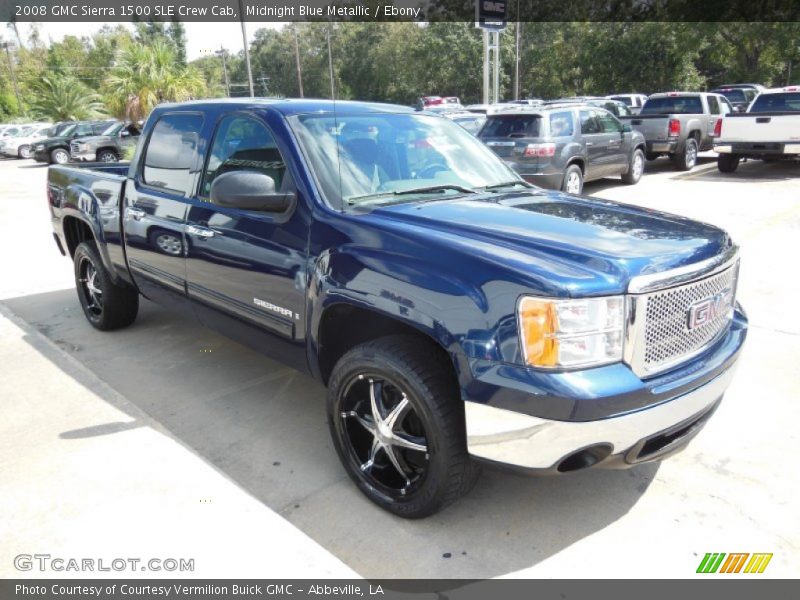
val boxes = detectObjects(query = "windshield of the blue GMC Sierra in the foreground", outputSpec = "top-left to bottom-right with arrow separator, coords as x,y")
290,113 -> 521,208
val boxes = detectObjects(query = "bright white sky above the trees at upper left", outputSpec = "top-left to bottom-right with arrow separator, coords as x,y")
12,22 -> 282,60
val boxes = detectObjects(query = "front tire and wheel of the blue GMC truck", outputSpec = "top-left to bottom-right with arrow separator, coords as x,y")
327,335 -> 479,519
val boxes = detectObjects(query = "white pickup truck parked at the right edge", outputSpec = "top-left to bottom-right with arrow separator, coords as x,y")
714,86 -> 800,173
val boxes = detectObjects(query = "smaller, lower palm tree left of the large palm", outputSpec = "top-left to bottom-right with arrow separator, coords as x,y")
31,74 -> 105,121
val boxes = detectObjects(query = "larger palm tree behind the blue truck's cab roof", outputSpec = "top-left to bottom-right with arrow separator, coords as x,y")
106,40 -> 205,121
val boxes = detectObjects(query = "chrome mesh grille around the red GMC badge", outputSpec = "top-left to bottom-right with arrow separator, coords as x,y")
641,263 -> 739,374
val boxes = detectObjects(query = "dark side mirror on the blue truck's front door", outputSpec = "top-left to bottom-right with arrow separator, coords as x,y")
211,171 -> 295,213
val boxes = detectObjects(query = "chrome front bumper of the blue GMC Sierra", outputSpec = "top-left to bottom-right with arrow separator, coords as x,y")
465,363 -> 736,470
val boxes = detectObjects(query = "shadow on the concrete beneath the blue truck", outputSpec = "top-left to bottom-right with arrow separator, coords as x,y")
5,289 -> 657,578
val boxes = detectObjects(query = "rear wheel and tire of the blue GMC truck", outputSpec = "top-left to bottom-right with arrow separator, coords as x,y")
74,242 -> 139,331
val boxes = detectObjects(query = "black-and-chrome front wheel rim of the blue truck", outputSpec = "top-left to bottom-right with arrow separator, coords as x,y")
335,372 -> 433,501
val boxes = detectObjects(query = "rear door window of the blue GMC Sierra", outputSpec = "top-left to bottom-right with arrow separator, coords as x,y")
142,114 -> 203,195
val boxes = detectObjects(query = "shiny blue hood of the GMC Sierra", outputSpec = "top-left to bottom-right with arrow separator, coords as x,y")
371,190 -> 732,295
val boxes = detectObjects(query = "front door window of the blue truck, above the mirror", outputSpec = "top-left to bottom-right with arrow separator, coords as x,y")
200,115 -> 291,197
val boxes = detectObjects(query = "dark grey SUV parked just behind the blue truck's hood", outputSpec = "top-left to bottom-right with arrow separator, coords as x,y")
478,103 -> 645,194
